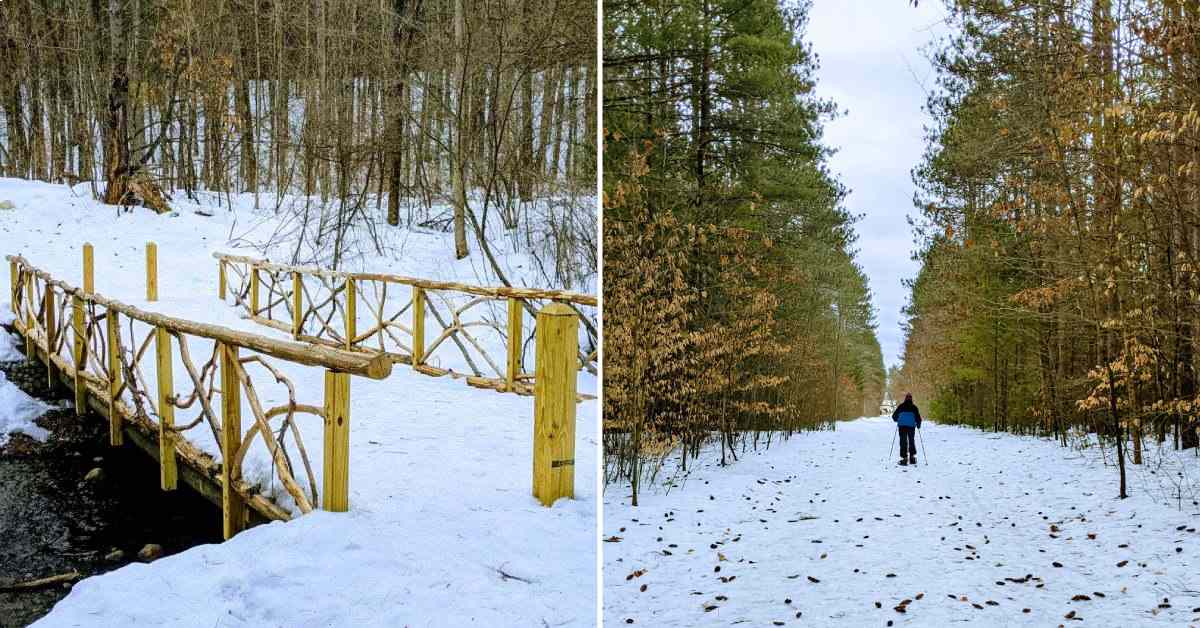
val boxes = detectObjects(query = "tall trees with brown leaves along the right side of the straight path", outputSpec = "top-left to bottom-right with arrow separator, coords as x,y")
895,0 -> 1200,497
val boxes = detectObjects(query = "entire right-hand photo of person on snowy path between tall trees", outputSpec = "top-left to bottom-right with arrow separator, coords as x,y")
601,0 -> 1200,628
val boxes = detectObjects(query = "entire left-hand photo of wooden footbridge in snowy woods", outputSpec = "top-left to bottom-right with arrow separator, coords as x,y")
0,0 -> 600,627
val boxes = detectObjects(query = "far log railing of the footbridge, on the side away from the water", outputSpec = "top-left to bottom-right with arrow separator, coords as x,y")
214,253 -> 598,399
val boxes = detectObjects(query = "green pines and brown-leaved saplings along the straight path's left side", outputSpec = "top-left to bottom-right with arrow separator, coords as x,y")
604,0 -> 884,504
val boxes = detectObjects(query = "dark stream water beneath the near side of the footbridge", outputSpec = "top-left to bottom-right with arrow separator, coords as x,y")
0,355 -> 221,627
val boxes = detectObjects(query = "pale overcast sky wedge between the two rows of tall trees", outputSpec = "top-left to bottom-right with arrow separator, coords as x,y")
806,0 -> 946,365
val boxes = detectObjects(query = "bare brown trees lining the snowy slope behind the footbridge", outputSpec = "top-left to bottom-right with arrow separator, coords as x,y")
0,0 -> 596,277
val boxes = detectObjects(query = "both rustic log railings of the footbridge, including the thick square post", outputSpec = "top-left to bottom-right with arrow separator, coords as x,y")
7,244 -> 596,538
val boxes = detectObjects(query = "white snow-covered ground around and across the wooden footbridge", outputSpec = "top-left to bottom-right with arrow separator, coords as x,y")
0,179 -> 598,626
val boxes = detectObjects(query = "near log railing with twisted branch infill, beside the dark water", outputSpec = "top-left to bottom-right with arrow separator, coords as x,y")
7,253 -> 392,538
